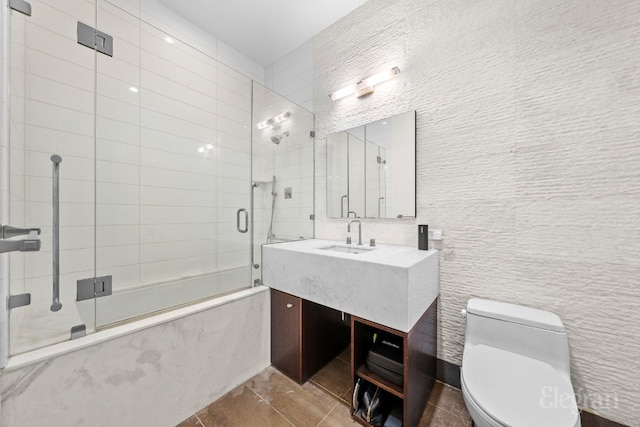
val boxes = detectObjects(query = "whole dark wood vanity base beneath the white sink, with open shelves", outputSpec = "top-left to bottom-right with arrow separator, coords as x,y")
271,289 -> 438,427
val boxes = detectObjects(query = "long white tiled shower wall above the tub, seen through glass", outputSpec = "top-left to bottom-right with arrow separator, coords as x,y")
3,0 -> 262,354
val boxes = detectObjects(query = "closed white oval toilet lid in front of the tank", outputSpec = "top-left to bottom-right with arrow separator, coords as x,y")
462,345 -> 578,427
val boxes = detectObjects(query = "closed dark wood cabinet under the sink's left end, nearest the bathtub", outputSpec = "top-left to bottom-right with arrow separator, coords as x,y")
271,289 -> 350,384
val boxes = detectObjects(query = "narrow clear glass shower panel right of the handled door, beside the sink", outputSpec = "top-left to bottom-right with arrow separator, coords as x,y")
251,84 -> 314,283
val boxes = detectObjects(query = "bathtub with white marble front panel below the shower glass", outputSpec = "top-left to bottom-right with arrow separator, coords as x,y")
0,278 -> 270,427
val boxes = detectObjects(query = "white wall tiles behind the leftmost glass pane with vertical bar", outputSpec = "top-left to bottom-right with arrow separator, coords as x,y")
8,1 -> 95,334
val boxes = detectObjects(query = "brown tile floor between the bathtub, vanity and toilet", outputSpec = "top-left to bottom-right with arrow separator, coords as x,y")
178,350 -> 471,427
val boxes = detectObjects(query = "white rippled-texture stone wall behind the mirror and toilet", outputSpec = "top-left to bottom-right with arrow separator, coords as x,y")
313,0 -> 640,426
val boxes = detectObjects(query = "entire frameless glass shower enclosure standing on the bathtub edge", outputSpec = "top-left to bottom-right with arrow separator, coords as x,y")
2,0 -> 314,355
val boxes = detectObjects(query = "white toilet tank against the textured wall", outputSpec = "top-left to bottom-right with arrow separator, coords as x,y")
462,298 -> 569,377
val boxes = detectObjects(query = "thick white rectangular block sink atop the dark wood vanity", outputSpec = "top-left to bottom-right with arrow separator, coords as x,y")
262,239 -> 440,332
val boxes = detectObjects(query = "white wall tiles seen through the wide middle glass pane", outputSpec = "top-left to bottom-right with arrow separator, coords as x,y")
92,3 -> 251,298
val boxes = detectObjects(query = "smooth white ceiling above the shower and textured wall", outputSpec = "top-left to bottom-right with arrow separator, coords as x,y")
159,0 -> 366,66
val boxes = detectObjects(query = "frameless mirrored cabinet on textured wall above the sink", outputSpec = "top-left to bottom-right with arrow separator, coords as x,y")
327,111 -> 416,218
